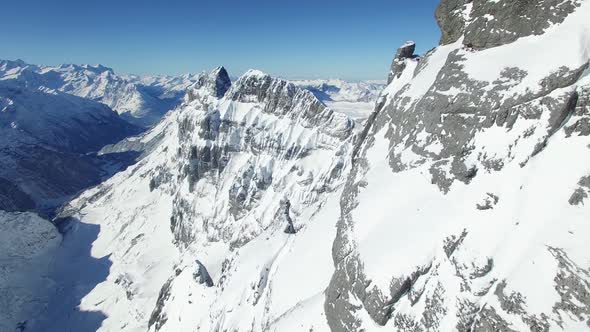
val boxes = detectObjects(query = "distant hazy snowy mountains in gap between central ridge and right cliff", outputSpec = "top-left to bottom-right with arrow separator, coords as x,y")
292,80 -> 385,124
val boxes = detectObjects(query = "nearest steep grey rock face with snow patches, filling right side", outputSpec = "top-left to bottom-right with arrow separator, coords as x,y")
325,0 -> 590,331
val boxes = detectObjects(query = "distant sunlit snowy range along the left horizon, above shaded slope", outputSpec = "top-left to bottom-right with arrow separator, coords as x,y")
0,60 -> 201,126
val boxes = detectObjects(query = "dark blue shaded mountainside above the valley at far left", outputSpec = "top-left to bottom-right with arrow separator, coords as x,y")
0,80 -> 139,212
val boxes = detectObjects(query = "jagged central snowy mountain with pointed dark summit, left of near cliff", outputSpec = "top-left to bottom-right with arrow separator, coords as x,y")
29,68 -> 354,331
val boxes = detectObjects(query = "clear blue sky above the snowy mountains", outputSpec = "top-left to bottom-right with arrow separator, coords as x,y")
0,0 -> 440,80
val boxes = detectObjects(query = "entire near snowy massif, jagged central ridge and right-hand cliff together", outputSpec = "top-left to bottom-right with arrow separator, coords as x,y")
3,0 -> 590,332
